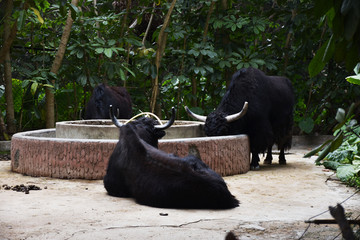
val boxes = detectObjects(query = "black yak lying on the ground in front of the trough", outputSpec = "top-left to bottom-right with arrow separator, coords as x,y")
104,106 -> 239,209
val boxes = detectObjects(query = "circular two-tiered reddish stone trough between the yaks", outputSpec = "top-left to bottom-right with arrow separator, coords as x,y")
11,120 -> 250,179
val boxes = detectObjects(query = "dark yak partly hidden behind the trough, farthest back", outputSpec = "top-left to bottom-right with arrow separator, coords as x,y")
85,83 -> 133,119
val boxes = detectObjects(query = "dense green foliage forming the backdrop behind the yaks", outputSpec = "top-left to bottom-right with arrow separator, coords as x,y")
0,0 -> 360,134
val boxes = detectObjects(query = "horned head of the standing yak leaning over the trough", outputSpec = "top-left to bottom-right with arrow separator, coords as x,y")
185,102 -> 248,136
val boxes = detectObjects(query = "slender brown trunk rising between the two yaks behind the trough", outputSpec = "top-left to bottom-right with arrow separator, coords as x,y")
150,0 -> 176,112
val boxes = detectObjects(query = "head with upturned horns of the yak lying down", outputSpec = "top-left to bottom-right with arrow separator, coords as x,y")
110,105 -> 175,148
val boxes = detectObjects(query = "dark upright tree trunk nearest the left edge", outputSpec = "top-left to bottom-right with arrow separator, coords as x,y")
4,0 -> 16,135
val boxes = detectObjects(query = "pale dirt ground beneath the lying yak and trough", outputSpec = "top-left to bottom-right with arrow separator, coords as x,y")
0,148 -> 360,240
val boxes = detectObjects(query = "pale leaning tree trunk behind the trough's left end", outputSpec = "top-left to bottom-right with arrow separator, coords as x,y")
45,0 -> 79,128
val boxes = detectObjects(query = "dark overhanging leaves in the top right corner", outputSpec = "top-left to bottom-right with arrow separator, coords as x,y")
309,0 -> 360,77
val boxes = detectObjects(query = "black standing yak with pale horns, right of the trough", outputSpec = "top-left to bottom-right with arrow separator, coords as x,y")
186,68 -> 294,169
